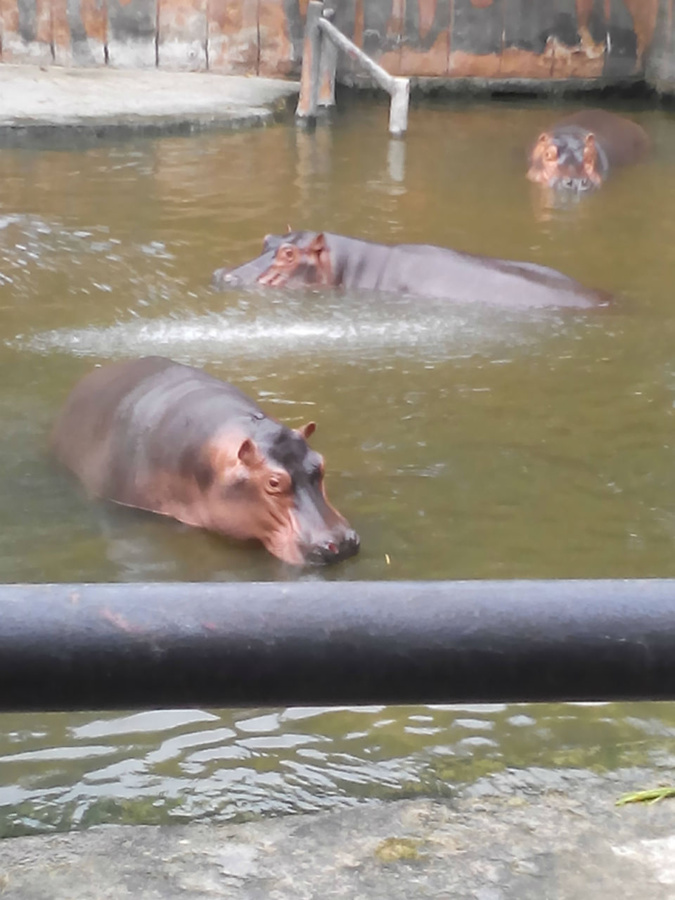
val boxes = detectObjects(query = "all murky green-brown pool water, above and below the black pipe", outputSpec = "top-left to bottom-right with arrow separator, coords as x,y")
0,103 -> 675,833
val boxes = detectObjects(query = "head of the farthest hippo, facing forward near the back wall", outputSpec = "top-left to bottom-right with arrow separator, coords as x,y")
527,128 -> 603,192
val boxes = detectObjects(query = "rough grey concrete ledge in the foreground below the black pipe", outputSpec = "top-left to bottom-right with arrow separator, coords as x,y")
0,768 -> 675,900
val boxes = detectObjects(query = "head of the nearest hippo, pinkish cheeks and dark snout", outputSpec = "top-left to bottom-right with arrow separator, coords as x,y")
201,417 -> 359,565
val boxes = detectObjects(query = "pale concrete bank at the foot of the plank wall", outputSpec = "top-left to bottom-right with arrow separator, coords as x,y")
0,64 -> 299,133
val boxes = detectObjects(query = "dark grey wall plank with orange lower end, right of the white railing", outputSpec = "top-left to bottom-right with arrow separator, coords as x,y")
448,0 -> 505,78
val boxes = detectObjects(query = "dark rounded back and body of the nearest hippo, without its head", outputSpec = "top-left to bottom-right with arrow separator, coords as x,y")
51,356 -> 265,508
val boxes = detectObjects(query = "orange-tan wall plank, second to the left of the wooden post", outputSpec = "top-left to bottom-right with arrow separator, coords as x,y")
206,0 -> 259,75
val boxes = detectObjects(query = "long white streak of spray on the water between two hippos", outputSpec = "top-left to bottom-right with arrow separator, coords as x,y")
15,298 -> 560,362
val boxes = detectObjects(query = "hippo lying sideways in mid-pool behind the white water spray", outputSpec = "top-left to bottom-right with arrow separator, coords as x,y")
212,231 -> 610,308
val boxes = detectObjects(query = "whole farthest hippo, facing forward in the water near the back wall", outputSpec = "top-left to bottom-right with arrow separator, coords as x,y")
527,109 -> 650,191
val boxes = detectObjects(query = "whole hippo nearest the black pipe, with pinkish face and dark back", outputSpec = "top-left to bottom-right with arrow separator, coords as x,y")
51,356 -> 359,565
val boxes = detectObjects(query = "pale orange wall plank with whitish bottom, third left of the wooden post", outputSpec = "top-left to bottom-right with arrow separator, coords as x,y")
157,0 -> 208,71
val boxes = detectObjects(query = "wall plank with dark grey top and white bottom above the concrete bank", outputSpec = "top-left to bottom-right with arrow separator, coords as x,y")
107,0 -> 157,69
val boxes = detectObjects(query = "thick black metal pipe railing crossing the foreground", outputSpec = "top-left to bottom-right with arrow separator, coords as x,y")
0,580 -> 675,710
